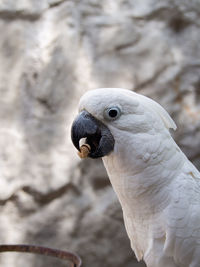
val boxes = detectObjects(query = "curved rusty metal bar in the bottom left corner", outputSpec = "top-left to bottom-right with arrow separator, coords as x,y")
0,244 -> 82,267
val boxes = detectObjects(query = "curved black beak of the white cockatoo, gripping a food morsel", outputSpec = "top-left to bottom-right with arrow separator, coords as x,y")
71,111 -> 115,158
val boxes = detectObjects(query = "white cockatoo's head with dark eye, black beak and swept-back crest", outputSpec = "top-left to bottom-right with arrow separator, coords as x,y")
71,88 -> 176,158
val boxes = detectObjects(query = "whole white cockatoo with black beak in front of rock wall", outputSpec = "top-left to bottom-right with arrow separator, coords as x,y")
71,88 -> 200,267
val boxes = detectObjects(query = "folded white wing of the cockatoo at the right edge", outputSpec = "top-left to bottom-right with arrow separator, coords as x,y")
164,158 -> 200,267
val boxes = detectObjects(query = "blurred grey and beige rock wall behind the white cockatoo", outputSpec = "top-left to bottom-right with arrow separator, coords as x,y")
0,0 -> 200,267
